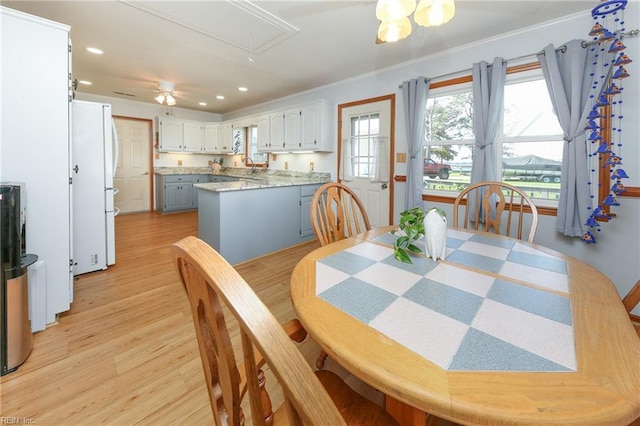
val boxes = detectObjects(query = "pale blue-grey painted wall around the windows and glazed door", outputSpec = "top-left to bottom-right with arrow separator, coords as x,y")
80,2 -> 640,302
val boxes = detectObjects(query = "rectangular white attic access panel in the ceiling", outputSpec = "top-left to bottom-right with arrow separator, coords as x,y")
119,0 -> 299,54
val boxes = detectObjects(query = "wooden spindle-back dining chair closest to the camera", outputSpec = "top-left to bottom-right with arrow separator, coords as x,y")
171,236 -> 397,426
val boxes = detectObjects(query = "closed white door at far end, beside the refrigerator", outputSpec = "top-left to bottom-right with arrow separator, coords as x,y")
113,118 -> 153,213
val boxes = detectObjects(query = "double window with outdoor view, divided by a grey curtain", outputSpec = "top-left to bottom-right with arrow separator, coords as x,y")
423,69 -> 563,206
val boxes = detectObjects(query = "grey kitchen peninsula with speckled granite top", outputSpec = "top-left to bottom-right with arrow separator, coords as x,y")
188,171 -> 330,264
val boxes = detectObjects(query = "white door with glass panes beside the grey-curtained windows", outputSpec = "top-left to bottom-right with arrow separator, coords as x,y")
338,95 -> 395,226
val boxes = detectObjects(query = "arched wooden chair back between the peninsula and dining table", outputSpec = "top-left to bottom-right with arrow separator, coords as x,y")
311,182 -> 371,246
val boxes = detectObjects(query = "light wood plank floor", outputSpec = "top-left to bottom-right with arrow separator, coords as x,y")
0,212 -> 381,426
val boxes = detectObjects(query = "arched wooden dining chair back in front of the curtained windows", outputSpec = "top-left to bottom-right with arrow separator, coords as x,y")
452,181 -> 538,243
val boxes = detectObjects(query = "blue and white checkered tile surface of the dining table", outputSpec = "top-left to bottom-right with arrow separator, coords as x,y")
316,229 -> 576,372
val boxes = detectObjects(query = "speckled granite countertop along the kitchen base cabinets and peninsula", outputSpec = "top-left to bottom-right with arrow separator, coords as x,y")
153,167 -> 331,192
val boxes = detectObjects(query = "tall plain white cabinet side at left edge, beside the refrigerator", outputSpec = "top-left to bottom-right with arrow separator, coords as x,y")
0,6 -> 74,323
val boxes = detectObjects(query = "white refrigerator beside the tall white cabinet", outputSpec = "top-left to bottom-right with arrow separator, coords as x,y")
71,101 -> 118,275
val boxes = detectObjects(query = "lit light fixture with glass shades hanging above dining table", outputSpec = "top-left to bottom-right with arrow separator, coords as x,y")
376,0 -> 456,42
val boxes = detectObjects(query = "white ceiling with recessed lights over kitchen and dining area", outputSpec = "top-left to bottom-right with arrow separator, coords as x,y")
2,0 -> 598,114
